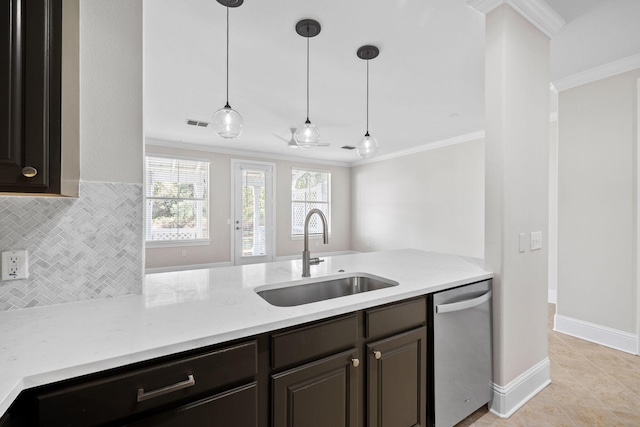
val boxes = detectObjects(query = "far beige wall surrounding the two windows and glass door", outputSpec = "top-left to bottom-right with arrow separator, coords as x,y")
145,145 -> 351,268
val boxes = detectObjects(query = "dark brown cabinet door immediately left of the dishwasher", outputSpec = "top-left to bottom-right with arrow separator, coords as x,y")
366,327 -> 427,427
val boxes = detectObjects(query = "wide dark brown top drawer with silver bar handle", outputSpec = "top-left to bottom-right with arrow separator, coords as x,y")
37,341 -> 257,426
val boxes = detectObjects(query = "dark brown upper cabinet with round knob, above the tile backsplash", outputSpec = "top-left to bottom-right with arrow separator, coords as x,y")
0,0 -> 62,194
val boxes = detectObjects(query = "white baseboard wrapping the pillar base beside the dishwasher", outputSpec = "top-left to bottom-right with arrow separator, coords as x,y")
489,358 -> 551,418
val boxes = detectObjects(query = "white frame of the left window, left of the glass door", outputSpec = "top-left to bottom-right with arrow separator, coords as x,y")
143,153 -> 212,248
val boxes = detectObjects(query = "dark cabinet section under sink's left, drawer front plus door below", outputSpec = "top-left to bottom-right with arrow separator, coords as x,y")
270,313 -> 362,427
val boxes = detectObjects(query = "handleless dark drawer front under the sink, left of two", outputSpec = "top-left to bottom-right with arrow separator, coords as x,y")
271,313 -> 358,369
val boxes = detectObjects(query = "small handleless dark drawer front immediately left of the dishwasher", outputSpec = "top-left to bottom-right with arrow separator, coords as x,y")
365,297 -> 427,338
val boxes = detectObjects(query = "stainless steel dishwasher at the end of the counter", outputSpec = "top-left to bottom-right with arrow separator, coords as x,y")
428,280 -> 493,427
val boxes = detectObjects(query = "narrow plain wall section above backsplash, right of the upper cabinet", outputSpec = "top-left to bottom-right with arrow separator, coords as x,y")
80,0 -> 144,183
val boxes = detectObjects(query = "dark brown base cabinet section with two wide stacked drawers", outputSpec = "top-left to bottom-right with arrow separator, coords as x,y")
34,341 -> 258,427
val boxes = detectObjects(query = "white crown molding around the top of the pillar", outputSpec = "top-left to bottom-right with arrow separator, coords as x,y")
467,0 -> 566,38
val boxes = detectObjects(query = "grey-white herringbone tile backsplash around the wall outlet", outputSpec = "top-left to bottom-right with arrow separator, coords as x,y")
0,182 -> 143,311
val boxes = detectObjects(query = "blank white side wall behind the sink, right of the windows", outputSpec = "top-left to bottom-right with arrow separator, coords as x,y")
351,140 -> 484,258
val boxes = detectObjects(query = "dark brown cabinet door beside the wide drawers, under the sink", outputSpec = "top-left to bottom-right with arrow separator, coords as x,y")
272,349 -> 360,427
